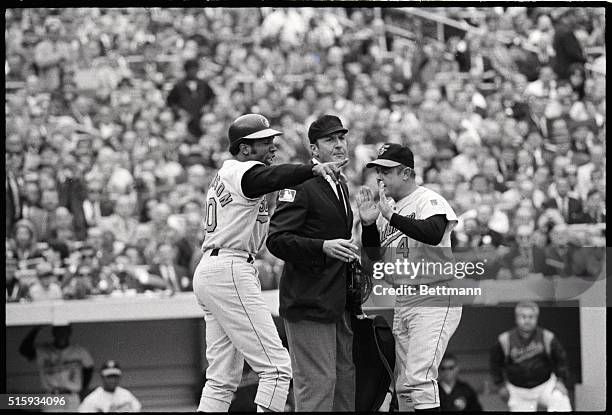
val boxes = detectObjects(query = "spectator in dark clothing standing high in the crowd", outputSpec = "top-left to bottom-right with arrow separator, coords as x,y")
167,59 -> 215,138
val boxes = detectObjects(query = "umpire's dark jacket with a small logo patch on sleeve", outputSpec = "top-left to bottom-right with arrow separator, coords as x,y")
267,176 -> 353,323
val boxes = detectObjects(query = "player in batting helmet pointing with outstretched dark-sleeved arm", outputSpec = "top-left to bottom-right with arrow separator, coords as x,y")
193,114 -> 347,412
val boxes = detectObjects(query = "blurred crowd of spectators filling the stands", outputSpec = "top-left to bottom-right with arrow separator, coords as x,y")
5,7 -> 606,301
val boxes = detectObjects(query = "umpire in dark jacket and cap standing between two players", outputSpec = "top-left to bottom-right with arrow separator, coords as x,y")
267,115 -> 358,412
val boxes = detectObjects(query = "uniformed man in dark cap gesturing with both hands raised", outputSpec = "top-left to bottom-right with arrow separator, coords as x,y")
357,144 -> 461,411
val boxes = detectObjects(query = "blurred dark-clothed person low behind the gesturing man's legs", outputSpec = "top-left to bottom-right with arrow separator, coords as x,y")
438,353 -> 482,412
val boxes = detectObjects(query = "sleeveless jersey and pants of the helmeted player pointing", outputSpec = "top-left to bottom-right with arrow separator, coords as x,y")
193,160 -> 291,412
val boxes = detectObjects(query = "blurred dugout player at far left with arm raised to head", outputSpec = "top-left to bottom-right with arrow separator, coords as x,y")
19,326 -> 94,412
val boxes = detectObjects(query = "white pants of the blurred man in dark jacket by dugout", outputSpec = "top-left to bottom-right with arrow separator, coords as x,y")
506,373 -> 572,412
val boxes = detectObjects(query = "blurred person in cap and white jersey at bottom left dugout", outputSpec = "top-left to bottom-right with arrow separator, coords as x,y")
79,360 -> 142,412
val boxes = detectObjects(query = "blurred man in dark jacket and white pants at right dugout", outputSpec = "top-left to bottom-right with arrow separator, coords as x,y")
490,301 -> 572,412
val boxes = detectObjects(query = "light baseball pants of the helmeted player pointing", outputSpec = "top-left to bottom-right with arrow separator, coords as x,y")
193,250 -> 291,412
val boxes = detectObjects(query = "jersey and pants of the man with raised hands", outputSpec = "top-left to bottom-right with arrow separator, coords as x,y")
377,186 -> 461,411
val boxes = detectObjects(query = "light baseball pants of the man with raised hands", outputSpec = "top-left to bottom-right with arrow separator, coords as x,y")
393,296 -> 462,411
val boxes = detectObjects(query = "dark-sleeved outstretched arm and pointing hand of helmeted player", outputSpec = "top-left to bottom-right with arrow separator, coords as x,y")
242,159 -> 348,199
